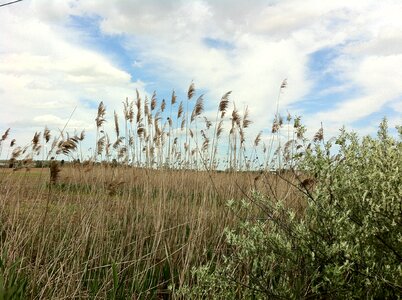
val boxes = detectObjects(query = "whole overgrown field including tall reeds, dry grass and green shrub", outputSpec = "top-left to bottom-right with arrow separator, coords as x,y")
0,81 -> 402,300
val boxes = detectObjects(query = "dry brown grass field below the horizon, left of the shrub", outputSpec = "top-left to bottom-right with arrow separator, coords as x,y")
0,166 -> 301,299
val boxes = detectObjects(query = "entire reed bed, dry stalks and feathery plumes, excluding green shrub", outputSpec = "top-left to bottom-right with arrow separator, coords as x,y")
0,82 -> 310,299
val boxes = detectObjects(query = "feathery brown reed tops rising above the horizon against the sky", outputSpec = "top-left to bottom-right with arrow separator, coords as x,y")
0,83 -> 296,171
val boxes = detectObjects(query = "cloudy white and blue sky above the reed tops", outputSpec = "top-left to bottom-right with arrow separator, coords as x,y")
0,0 -> 402,155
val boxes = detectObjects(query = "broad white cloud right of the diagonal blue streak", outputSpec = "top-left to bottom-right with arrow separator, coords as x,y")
74,1 -> 401,121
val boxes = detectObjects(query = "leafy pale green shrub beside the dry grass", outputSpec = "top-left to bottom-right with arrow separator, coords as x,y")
178,120 -> 402,299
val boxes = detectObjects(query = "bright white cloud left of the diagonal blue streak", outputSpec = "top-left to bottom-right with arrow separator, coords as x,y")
0,1 -> 143,150
